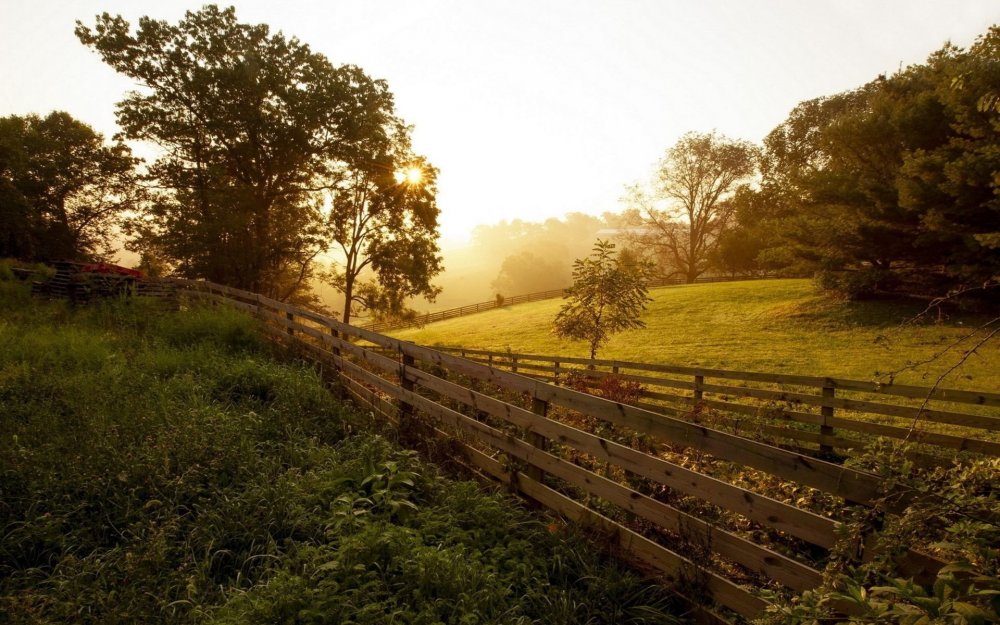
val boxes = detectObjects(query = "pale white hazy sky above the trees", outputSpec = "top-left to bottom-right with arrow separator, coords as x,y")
0,0 -> 1000,240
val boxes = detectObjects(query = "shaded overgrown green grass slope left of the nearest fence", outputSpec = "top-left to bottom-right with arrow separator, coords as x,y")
0,275 -> 676,625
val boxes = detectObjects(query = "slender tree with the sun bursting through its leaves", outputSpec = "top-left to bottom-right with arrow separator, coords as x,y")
328,126 -> 442,323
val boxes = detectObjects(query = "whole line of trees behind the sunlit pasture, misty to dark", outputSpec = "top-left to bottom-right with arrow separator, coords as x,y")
450,26 -> 1000,301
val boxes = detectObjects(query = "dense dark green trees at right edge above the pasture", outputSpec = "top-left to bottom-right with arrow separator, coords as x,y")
754,26 -> 1000,297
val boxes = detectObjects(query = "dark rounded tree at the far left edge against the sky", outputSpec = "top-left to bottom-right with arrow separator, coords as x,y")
0,112 -> 140,261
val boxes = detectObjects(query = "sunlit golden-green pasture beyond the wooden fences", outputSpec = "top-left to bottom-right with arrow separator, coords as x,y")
391,280 -> 1000,390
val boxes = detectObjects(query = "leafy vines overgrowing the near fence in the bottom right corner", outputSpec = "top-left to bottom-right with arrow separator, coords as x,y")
768,454 -> 1000,625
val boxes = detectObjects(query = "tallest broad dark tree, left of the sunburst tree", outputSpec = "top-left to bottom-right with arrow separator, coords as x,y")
76,5 -> 395,298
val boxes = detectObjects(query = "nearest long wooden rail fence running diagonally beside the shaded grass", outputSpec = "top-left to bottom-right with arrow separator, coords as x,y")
170,281 -> 976,620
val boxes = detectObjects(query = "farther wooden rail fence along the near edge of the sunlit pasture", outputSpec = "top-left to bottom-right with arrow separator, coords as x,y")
437,348 -> 1000,463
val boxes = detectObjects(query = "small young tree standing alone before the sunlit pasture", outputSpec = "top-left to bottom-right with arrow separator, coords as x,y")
553,239 -> 653,360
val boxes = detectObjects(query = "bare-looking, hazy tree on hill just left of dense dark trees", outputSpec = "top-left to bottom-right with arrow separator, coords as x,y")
626,132 -> 756,282
